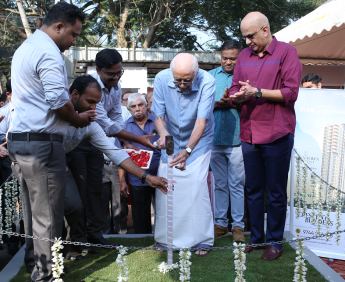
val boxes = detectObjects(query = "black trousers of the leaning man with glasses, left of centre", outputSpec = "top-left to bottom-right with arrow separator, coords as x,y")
67,140 -> 105,242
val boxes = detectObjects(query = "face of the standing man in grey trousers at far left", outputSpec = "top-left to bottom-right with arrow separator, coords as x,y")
56,19 -> 82,52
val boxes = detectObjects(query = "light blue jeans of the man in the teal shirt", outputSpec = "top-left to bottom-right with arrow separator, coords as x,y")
210,145 -> 245,228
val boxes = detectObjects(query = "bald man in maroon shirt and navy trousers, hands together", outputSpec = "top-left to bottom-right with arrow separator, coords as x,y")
225,12 -> 302,260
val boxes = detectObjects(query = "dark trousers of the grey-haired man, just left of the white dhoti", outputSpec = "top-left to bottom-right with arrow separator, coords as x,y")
130,185 -> 155,234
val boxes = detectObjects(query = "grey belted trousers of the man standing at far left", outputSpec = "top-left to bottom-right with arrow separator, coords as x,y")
7,140 -> 66,281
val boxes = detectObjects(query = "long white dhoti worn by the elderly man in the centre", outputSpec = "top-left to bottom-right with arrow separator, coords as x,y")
155,150 -> 214,248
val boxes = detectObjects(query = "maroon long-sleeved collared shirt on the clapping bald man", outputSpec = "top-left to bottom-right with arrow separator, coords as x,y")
229,37 -> 302,144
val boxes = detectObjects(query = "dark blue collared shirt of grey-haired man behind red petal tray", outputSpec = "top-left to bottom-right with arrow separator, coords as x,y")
115,113 -> 161,186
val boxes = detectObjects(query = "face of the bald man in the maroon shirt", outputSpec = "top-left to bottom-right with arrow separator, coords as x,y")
241,25 -> 268,53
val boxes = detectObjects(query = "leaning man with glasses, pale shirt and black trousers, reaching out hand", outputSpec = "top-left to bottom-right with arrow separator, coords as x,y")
68,49 -> 155,245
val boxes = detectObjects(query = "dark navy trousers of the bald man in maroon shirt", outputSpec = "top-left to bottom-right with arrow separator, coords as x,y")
242,133 -> 294,248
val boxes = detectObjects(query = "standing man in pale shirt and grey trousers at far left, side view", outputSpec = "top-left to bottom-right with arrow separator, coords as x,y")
7,2 -> 97,281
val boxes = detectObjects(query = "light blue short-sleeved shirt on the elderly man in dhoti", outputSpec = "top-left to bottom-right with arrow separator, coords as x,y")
151,69 -> 216,165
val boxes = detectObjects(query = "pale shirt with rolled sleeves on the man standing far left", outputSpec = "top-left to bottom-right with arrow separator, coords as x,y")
10,30 -> 69,135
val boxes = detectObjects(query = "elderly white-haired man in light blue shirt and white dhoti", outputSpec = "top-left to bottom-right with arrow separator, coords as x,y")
152,53 -> 215,255
